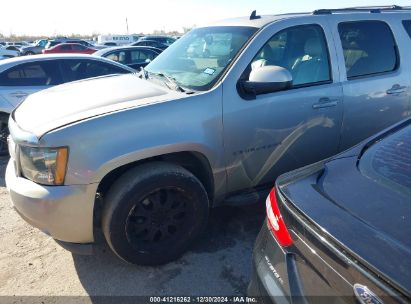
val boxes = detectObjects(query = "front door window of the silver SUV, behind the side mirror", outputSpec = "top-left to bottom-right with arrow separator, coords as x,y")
251,24 -> 331,87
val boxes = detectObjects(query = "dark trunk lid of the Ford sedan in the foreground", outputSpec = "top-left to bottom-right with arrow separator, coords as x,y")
280,156 -> 411,295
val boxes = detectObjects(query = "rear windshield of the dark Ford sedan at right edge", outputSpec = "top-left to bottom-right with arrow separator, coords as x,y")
359,125 -> 411,198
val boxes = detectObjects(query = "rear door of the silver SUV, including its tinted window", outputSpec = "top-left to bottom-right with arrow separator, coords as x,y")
329,13 -> 411,151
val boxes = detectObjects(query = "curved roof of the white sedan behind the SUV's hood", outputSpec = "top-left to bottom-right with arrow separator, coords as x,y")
0,54 -> 135,72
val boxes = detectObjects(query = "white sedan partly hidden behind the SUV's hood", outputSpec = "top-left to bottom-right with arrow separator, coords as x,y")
0,54 -> 135,154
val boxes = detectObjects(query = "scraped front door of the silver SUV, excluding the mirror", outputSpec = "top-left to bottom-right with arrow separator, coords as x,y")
223,16 -> 343,192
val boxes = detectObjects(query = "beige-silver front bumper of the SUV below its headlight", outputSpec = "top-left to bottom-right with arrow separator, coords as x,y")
6,160 -> 98,247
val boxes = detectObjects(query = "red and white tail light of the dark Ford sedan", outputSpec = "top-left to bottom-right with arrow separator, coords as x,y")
265,188 -> 293,247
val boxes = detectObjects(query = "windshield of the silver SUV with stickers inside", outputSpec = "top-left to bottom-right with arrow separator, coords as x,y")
146,26 -> 257,91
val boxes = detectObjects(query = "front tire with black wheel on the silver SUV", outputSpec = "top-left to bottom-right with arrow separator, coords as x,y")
102,162 -> 209,265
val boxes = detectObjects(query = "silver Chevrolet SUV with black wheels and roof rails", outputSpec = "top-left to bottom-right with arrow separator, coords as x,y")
6,7 -> 411,264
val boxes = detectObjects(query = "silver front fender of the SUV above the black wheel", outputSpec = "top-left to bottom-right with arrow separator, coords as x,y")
40,88 -> 225,194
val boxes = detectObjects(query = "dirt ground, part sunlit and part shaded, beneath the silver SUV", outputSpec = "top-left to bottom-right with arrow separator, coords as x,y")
0,158 -> 264,303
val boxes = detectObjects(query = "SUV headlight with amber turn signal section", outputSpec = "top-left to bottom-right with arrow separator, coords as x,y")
20,147 -> 68,185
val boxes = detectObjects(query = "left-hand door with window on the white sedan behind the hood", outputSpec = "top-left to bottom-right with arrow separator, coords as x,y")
0,60 -> 62,107
